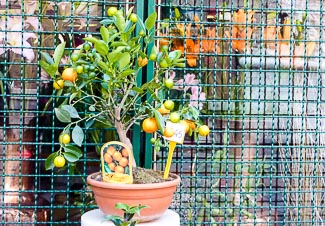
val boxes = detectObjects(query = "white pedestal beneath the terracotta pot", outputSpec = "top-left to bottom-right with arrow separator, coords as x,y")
81,209 -> 180,226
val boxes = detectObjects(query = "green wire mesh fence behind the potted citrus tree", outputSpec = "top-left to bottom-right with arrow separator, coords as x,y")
0,0 -> 325,225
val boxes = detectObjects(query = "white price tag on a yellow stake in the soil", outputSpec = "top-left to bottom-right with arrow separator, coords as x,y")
164,121 -> 186,179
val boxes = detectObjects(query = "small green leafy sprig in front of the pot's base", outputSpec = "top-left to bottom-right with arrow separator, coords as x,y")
104,203 -> 148,226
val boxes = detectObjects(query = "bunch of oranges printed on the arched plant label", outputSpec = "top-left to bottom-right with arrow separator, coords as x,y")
104,146 -> 129,173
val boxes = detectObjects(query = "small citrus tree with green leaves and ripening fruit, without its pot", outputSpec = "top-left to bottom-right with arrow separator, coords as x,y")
41,7 -> 207,169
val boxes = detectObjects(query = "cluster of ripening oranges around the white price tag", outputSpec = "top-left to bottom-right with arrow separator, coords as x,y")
142,100 -> 210,137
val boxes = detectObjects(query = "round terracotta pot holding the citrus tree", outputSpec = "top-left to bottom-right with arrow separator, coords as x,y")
87,172 -> 181,222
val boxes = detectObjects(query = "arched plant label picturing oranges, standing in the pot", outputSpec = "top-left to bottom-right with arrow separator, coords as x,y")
101,141 -> 133,184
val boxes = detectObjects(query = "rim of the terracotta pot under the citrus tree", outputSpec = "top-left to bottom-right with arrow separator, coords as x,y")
87,172 -> 181,190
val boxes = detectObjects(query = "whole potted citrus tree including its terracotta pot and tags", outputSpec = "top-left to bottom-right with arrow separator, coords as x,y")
41,7 -> 209,221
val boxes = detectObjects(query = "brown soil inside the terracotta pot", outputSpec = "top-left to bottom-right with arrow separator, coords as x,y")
93,167 -> 175,184
